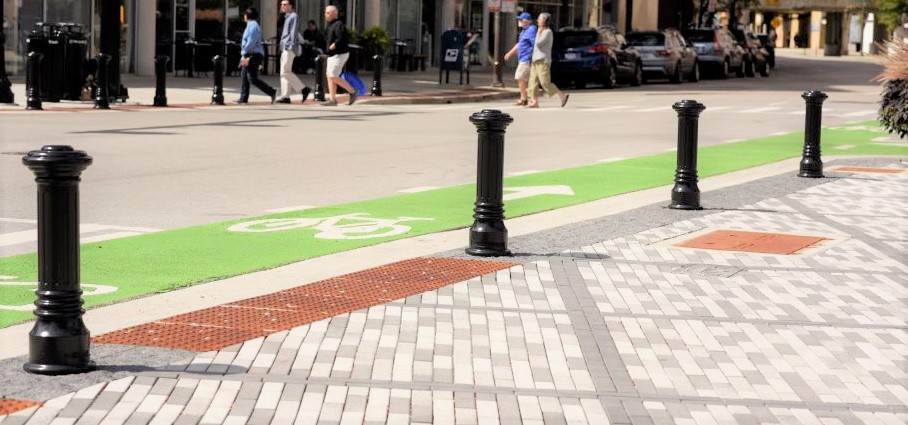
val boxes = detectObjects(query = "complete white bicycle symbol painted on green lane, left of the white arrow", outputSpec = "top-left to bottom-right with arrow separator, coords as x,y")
227,213 -> 434,239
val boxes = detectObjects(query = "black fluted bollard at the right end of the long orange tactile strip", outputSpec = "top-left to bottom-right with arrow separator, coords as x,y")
466,109 -> 514,257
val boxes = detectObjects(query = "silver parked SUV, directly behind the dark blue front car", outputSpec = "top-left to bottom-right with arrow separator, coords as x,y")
625,29 -> 700,84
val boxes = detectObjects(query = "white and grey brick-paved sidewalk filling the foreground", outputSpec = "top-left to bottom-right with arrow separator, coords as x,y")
0,158 -> 908,425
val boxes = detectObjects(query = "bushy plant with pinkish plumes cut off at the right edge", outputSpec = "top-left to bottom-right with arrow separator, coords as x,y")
876,40 -> 908,138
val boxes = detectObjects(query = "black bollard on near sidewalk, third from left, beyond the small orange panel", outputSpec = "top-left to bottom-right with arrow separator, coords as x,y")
668,100 -> 706,210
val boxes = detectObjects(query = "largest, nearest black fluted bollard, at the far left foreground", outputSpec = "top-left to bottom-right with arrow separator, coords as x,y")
22,146 -> 94,375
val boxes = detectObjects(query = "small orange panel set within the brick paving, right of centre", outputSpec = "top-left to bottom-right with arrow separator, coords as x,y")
675,230 -> 826,255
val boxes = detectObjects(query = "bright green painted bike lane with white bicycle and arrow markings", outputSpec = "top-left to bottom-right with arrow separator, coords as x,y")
0,122 -> 908,328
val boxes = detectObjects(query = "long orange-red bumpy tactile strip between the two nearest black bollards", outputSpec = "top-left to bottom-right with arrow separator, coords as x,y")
92,257 -> 517,351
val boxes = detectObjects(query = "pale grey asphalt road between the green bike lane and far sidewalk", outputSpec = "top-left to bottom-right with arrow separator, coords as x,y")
0,51 -> 881,256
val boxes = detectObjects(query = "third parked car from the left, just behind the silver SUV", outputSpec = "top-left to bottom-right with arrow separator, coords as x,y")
681,28 -> 744,80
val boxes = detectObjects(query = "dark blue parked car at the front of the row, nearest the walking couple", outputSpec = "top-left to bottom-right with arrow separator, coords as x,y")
552,27 -> 643,88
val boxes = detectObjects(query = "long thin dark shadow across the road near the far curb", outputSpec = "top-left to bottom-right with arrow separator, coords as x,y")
71,109 -> 402,136
